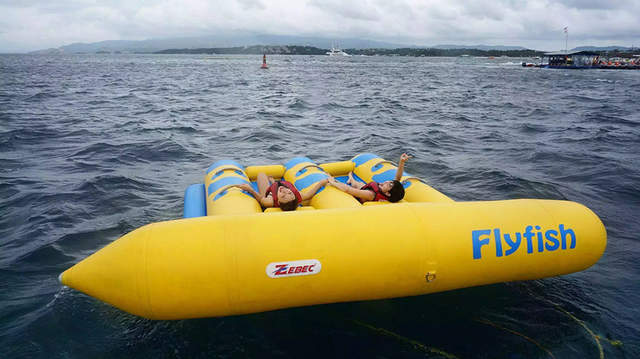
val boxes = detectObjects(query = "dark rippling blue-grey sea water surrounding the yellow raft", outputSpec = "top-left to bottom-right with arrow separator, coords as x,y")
0,55 -> 640,358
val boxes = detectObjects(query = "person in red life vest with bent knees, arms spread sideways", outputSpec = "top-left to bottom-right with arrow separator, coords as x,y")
236,173 -> 328,211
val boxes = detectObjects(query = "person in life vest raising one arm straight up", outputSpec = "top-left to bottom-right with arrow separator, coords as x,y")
329,153 -> 411,203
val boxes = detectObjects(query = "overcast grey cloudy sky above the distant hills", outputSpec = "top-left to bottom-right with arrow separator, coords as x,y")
0,0 -> 640,52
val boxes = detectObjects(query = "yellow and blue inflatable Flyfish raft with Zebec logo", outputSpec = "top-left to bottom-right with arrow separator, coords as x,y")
60,154 -> 606,319
